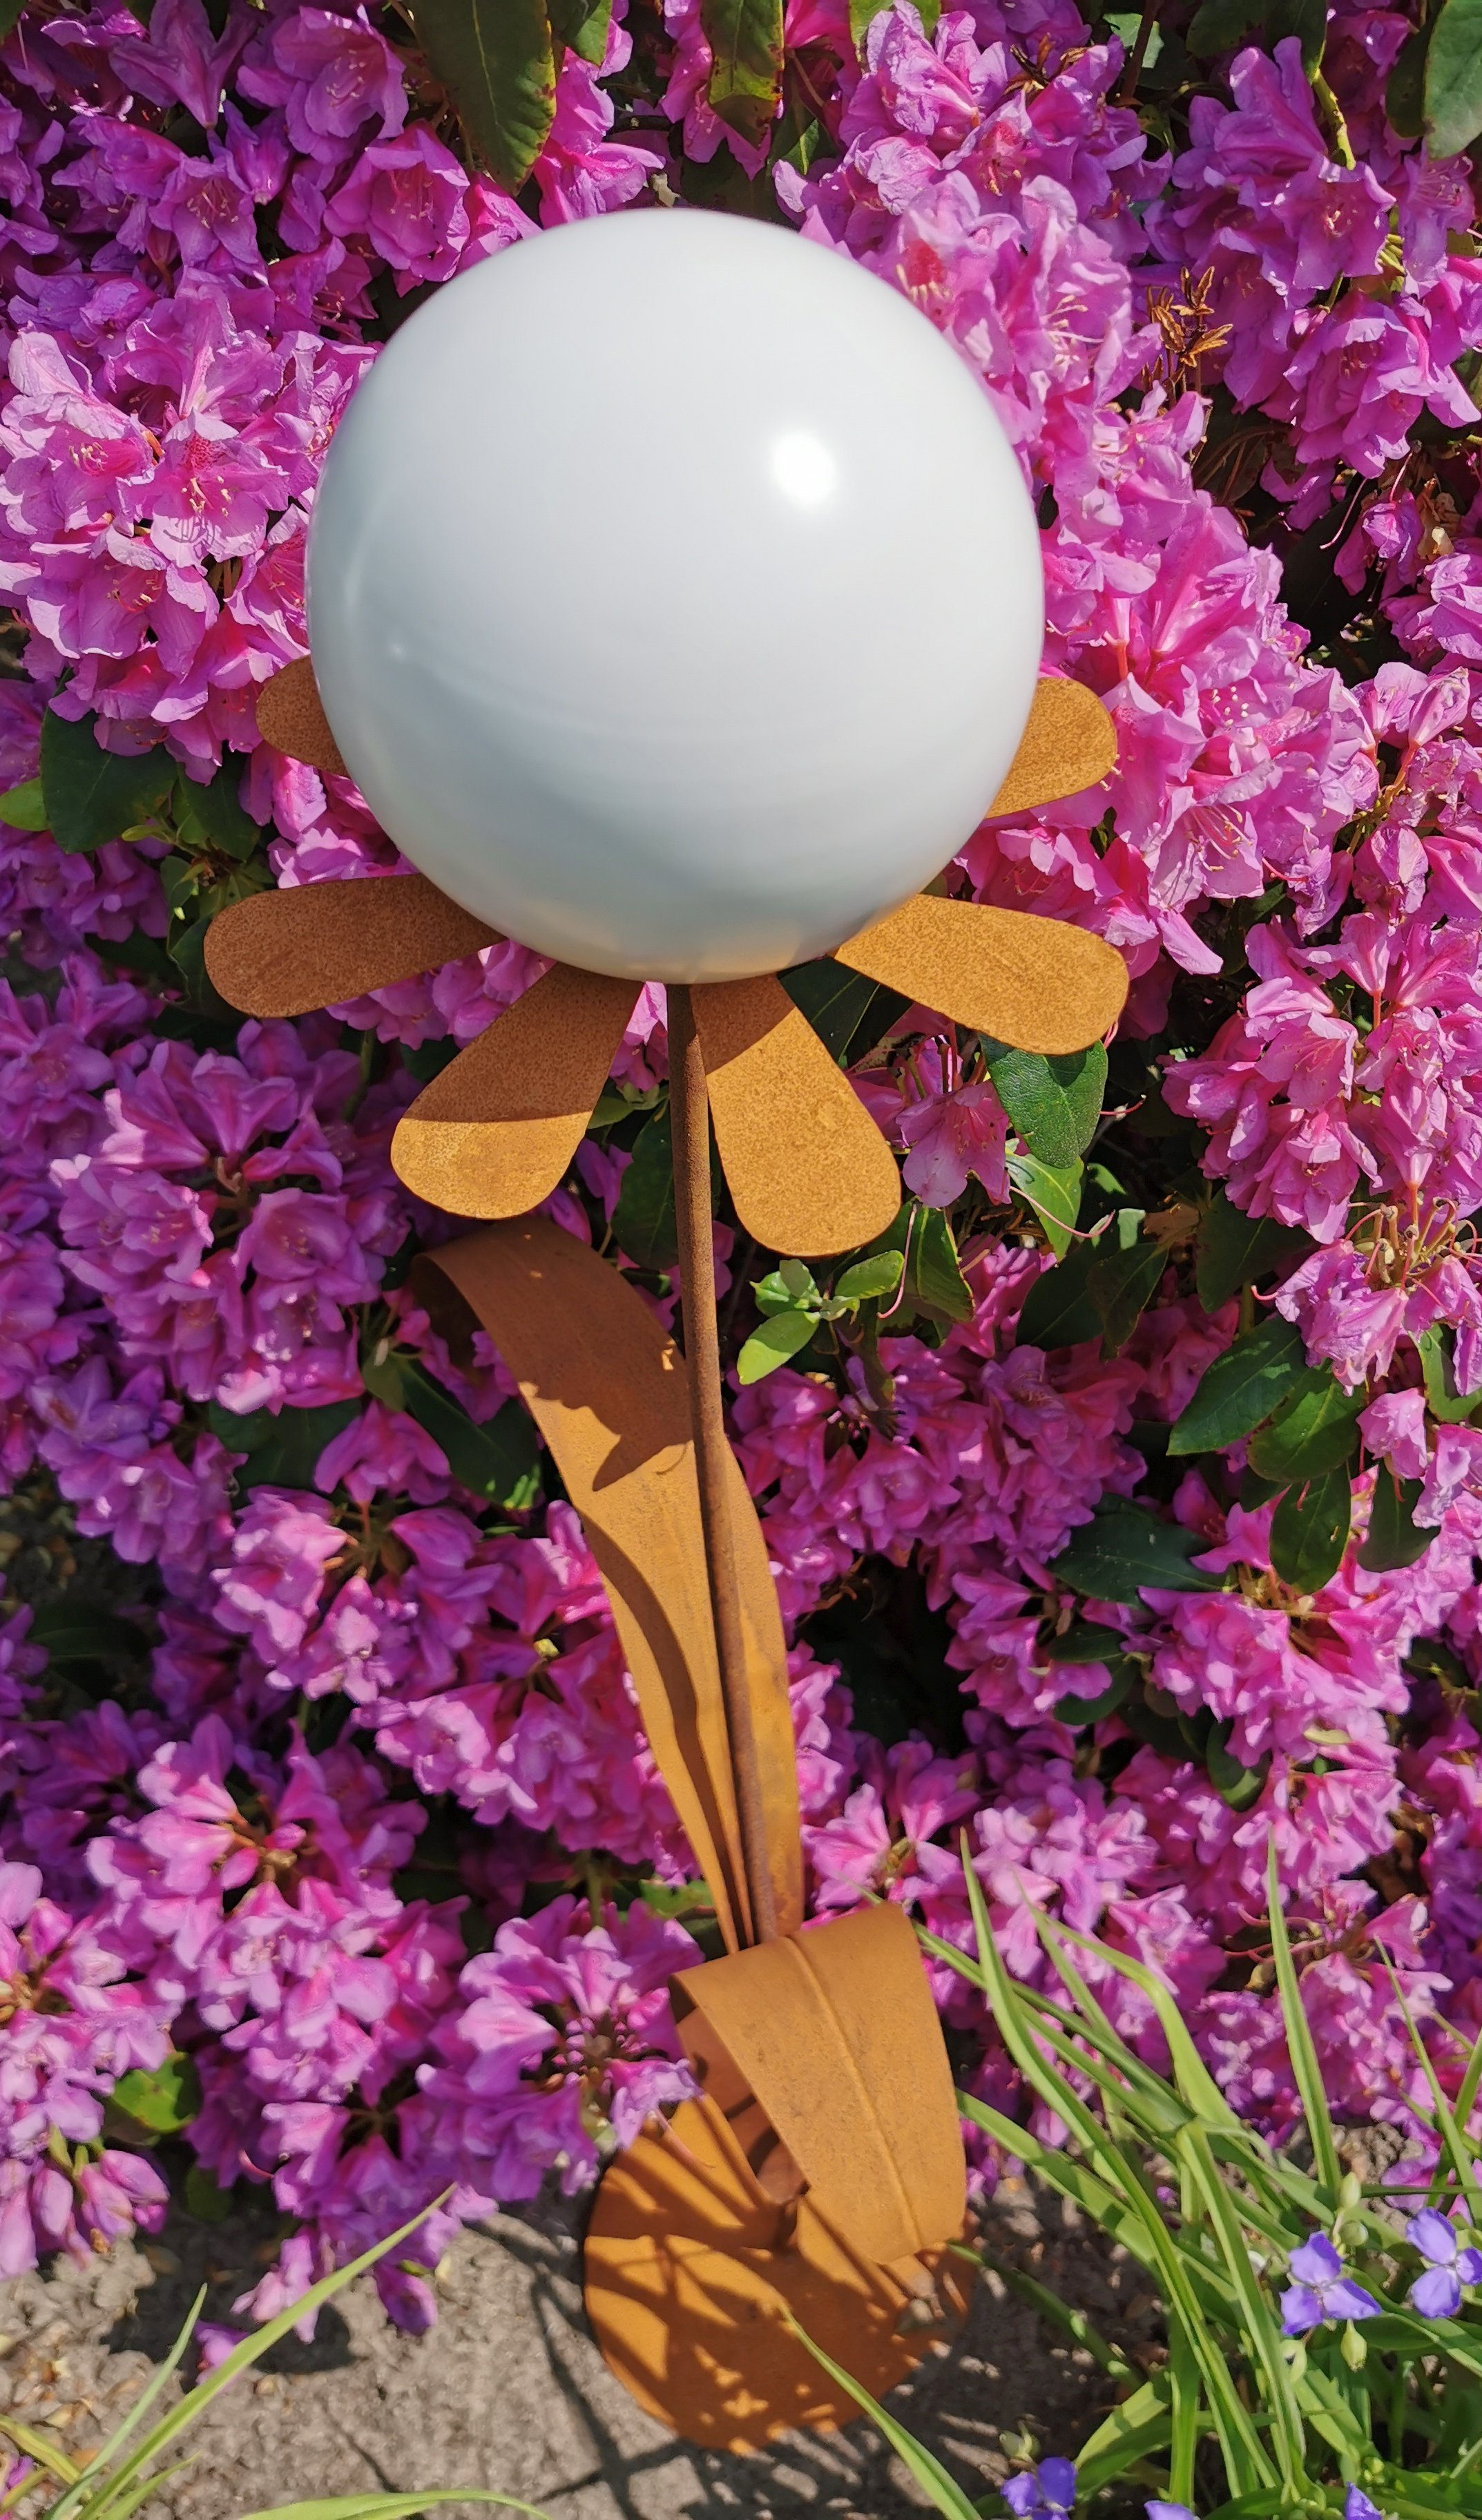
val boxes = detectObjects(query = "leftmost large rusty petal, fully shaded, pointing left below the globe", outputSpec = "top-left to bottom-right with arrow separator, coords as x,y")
206,875 -> 499,1015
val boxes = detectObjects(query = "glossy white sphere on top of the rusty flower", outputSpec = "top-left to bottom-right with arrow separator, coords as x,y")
307,209 -> 1043,980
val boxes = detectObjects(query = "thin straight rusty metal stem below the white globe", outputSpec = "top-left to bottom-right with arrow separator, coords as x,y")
668,980 -> 776,1943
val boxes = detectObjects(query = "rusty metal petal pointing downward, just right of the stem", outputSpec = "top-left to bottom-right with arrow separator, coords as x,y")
693,977 -> 900,1257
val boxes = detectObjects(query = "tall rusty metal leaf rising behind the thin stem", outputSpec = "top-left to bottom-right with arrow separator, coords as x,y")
414,1217 -> 802,1951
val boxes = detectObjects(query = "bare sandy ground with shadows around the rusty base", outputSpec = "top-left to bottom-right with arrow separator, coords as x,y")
0,2182 -> 1152,2520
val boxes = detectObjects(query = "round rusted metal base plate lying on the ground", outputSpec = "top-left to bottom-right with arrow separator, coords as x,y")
587,2099 -> 970,2452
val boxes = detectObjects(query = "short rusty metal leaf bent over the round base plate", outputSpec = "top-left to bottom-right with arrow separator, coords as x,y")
675,1905 -> 968,2266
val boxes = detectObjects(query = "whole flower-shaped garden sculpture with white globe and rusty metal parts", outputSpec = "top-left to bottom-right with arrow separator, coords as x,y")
206,214 -> 1126,2447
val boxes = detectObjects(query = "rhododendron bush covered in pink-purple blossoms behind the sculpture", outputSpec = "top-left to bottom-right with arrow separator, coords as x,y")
0,0 -> 1482,2326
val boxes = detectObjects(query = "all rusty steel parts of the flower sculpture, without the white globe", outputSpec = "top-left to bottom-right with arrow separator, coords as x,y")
206,660 -> 1126,2450
